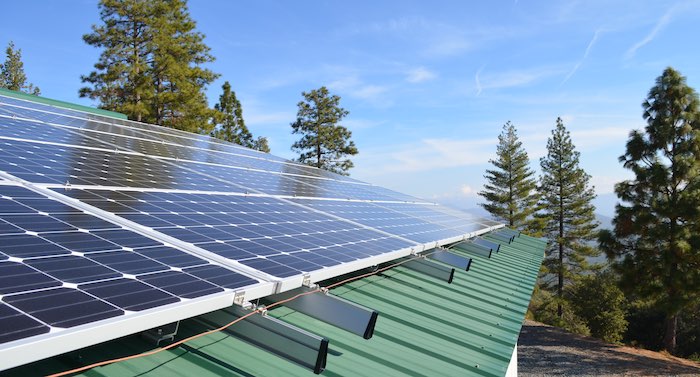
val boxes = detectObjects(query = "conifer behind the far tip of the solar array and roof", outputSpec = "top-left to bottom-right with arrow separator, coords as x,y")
479,121 -> 537,230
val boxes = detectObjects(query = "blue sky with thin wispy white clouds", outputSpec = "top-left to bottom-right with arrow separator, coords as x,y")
0,0 -> 700,216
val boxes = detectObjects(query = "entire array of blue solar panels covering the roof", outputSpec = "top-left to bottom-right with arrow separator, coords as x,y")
0,95 -> 498,370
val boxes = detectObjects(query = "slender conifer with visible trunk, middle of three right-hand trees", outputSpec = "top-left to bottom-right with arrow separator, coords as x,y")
537,118 -> 599,318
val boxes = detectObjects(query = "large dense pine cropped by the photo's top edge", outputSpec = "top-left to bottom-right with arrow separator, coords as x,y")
80,0 -> 217,133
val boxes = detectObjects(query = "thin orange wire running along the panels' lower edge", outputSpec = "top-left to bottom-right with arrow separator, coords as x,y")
47,253 -> 432,377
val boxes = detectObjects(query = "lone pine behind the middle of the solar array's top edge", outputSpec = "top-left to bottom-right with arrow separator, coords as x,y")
292,86 -> 357,175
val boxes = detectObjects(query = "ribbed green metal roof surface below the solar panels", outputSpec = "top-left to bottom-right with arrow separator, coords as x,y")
2,231 -> 545,376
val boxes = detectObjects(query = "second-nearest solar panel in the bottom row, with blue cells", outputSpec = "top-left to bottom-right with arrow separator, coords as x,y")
54,188 -> 416,277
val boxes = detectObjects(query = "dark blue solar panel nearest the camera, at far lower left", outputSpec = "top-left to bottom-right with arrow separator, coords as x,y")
0,182 -> 259,343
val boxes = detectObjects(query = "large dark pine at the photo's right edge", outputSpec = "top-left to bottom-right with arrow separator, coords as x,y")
599,68 -> 700,352
